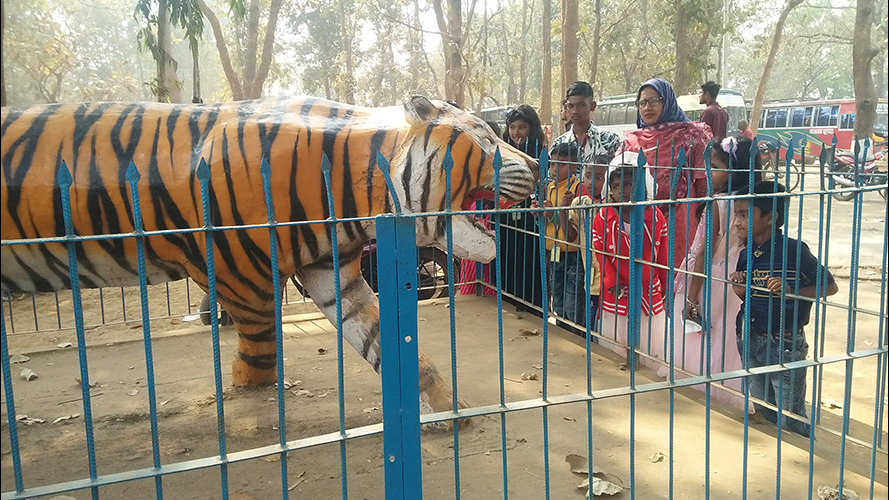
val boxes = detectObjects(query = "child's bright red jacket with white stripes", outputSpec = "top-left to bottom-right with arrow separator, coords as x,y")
592,205 -> 670,316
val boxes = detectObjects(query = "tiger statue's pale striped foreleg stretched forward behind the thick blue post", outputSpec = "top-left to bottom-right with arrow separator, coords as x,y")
297,247 -> 467,418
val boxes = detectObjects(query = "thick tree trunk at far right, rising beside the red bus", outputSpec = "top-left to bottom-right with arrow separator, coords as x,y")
852,0 -> 881,140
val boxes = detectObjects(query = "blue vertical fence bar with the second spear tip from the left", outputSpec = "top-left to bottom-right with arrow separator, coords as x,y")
125,161 -> 169,500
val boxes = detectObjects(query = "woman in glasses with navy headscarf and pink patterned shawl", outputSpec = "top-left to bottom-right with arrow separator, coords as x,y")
624,78 -> 713,268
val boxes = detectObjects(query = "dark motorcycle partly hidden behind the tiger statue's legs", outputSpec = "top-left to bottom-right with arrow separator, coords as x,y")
199,240 -> 460,326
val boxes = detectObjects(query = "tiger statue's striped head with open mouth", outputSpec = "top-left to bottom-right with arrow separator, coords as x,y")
390,96 -> 538,262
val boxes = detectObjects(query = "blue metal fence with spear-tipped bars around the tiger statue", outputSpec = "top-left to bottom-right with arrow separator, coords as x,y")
0,135 -> 889,500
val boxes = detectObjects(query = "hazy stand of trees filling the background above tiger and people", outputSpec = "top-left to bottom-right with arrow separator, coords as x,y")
0,0 -> 889,131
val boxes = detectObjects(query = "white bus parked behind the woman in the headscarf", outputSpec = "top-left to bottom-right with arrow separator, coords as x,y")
593,89 -> 747,137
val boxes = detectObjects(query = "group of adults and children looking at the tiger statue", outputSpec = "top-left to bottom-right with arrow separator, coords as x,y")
463,78 -> 837,435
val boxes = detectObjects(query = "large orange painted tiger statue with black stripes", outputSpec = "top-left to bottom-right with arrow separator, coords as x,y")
0,96 -> 538,411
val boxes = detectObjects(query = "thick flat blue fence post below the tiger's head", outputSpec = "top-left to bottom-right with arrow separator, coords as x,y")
376,216 -> 422,500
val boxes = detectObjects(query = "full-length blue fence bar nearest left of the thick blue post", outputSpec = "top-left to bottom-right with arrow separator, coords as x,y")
321,153 -> 348,500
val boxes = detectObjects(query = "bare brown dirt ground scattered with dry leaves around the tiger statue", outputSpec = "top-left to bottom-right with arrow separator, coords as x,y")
0,287 -> 887,499
